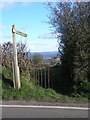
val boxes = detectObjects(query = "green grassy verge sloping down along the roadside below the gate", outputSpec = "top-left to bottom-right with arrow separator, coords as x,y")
2,69 -> 88,103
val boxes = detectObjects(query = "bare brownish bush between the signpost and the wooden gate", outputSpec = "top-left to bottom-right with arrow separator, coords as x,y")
17,43 -> 31,77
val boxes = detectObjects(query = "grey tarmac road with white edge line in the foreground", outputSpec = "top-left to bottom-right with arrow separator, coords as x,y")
2,105 -> 88,118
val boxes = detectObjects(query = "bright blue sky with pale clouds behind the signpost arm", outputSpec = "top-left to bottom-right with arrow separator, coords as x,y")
0,2 -> 58,52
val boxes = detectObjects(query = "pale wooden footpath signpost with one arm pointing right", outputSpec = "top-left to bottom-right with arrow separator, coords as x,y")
12,25 -> 27,89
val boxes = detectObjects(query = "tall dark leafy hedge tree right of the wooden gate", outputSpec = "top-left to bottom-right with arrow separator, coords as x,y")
48,2 -> 90,93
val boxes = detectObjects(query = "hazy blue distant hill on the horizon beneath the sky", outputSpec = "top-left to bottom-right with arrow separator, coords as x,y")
28,51 -> 58,59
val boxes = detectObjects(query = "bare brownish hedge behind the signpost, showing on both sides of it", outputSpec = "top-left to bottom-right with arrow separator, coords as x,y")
2,42 -> 31,77
